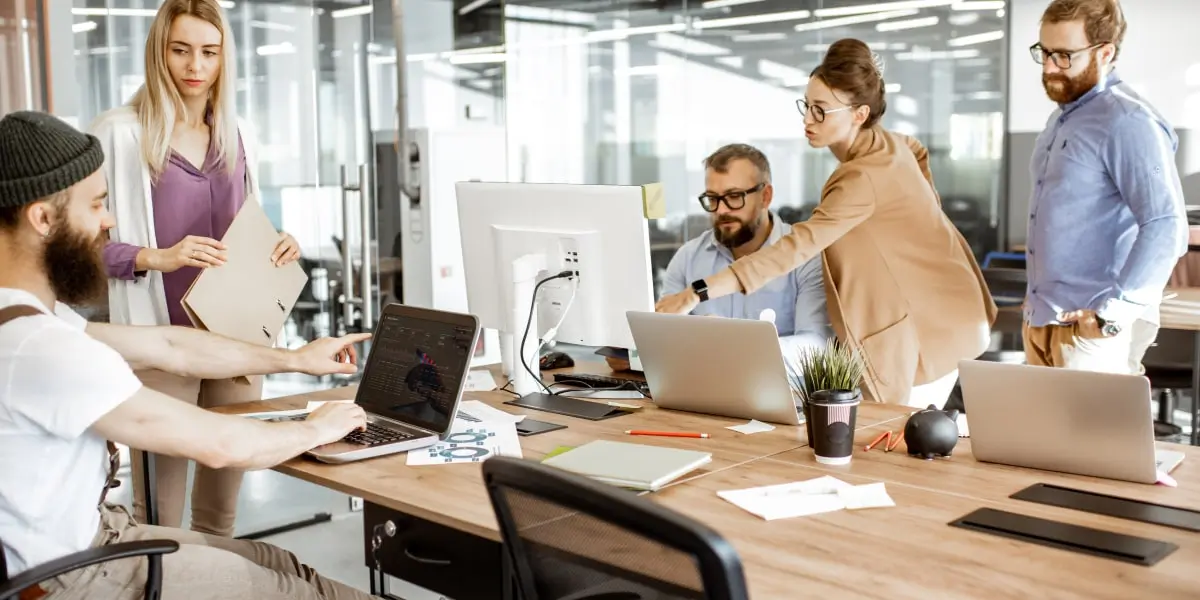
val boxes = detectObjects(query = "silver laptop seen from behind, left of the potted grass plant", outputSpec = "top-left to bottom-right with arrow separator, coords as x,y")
625,311 -> 802,425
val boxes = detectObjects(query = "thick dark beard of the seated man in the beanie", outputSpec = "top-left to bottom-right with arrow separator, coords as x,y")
42,224 -> 108,306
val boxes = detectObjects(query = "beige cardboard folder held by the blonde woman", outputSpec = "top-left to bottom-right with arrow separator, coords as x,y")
184,199 -> 308,383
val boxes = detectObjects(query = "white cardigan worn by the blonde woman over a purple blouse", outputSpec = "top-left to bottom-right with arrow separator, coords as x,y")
90,106 -> 260,325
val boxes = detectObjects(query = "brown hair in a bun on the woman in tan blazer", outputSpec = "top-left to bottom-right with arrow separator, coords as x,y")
809,37 -> 888,130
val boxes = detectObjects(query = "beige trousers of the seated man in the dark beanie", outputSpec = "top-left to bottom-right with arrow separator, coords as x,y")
42,504 -> 372,600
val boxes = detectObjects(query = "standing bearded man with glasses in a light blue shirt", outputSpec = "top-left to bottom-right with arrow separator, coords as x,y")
1024,0 -> 1188,373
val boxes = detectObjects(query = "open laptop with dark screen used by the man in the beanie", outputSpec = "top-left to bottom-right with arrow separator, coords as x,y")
264,304 -> 479,463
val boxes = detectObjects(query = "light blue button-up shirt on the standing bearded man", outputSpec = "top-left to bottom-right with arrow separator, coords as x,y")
1025,72 -> 1188,326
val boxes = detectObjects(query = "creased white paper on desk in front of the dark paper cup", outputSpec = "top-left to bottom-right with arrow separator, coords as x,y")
716,475 -> 895,521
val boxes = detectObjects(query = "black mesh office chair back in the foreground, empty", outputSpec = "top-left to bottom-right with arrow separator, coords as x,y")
484,457 -> 749,600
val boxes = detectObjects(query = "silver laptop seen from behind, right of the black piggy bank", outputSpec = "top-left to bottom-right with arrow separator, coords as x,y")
959,360 -> 1183,484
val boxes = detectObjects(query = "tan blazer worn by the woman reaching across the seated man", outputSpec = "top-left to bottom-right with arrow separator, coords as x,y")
732,127 -> 996,403
